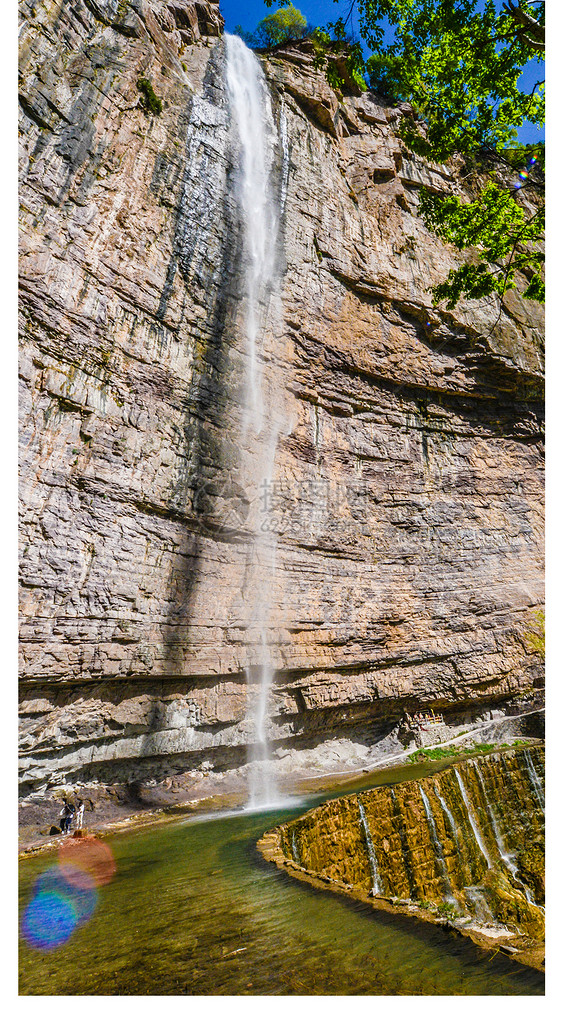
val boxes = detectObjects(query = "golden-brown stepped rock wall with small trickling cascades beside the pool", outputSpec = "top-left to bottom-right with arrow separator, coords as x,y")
259,744 -> 545,966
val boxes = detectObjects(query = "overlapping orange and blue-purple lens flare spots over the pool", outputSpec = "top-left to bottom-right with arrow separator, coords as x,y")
21,838 -> 116,950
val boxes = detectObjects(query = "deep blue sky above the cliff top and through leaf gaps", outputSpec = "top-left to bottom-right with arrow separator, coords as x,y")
220,0 -> 545,144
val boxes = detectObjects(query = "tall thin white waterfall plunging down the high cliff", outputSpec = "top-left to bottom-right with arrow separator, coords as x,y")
224,35 -> 282,808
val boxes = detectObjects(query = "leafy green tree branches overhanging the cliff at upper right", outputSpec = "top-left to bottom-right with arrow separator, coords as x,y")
266,0 -> 545,307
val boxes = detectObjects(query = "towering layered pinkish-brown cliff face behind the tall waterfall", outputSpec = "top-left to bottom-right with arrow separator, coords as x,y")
19,0 -> 542,791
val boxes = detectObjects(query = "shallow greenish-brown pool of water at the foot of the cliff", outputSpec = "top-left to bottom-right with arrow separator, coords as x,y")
20,762 -> 544,996
